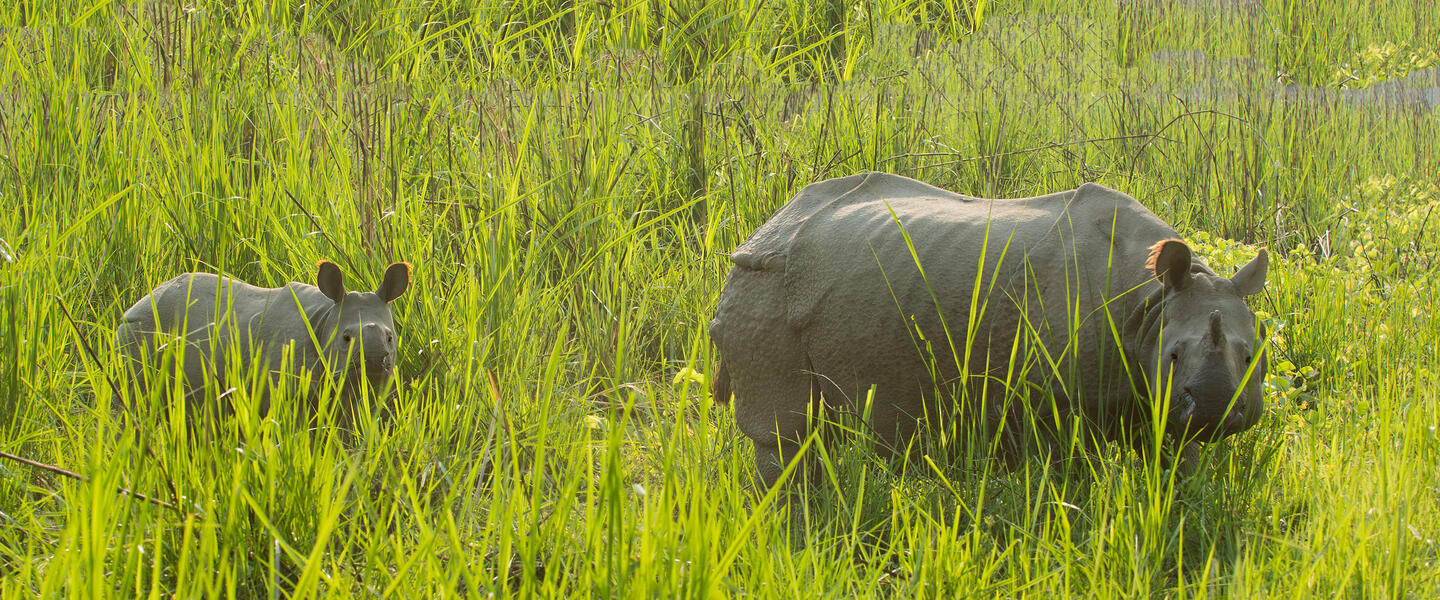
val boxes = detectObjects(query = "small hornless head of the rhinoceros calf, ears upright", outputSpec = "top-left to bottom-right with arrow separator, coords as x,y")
315,260 -> 410,387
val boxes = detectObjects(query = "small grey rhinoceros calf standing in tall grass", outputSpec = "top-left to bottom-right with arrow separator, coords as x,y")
115,260 -> 410,413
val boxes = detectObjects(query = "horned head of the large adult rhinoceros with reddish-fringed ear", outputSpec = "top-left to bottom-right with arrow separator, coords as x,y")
1128,239 -> 1270,440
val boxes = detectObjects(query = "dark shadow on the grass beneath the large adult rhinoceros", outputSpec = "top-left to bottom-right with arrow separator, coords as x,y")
778,405 -> 1284,593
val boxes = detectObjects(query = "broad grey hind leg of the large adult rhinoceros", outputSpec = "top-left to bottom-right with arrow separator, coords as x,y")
711,268 -> 812,486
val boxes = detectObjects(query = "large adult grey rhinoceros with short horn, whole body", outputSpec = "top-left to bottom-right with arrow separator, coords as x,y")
710,173 -> 1269,485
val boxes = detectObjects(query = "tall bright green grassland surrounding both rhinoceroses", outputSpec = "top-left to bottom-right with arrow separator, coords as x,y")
0,0 -> 1440,599
